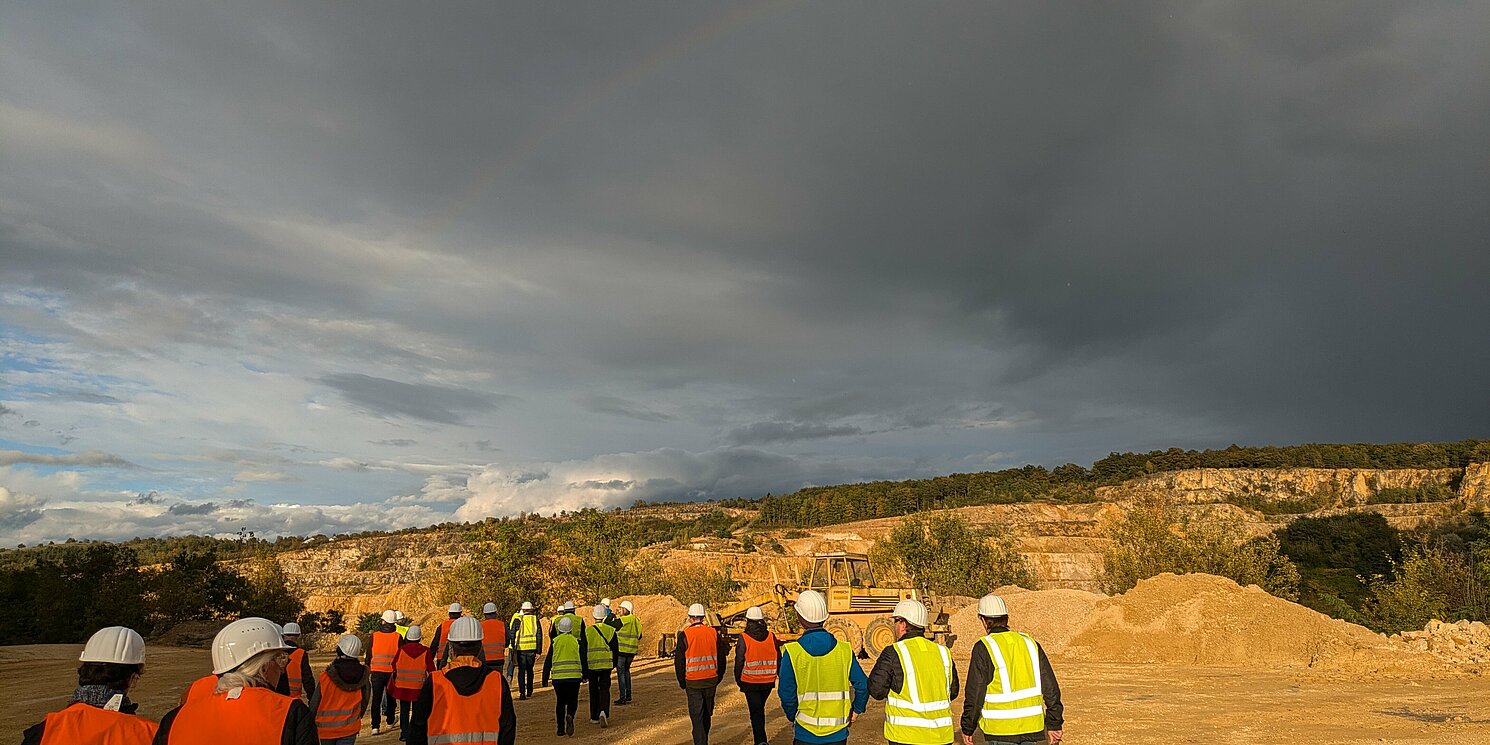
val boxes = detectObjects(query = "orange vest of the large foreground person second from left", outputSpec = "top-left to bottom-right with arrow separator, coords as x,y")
165,688 -> 295,745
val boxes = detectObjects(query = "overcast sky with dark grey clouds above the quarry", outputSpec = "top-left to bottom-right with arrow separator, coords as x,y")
0,0 -> 1490,545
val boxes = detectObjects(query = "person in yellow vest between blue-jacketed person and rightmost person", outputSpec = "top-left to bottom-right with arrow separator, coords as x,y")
869,599 -> 958,745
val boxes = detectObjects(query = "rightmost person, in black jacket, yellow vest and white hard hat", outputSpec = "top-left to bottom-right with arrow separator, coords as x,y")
961,595 -> 1065,745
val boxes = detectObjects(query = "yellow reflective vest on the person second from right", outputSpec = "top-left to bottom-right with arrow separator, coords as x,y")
885,636 -> 955,745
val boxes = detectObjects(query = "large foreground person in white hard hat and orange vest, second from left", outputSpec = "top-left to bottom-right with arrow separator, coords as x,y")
155,618 -> 317,745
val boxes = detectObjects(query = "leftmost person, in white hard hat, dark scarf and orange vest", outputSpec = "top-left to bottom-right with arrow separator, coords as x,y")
21,626 -> 156,745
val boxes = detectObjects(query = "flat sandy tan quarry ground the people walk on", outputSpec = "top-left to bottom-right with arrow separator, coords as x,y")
0,645 -> 1490,745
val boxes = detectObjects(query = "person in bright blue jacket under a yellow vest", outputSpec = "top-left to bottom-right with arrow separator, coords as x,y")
776,590 -> 869,745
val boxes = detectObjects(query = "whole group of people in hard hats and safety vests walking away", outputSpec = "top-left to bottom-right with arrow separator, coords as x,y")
22,590 -> 1064,745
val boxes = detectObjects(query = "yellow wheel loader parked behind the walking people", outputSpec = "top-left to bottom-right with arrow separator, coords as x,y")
657,551 -> 957,657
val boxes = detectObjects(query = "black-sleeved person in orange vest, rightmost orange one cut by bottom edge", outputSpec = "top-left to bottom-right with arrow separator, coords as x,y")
407,617 -> 517,745
